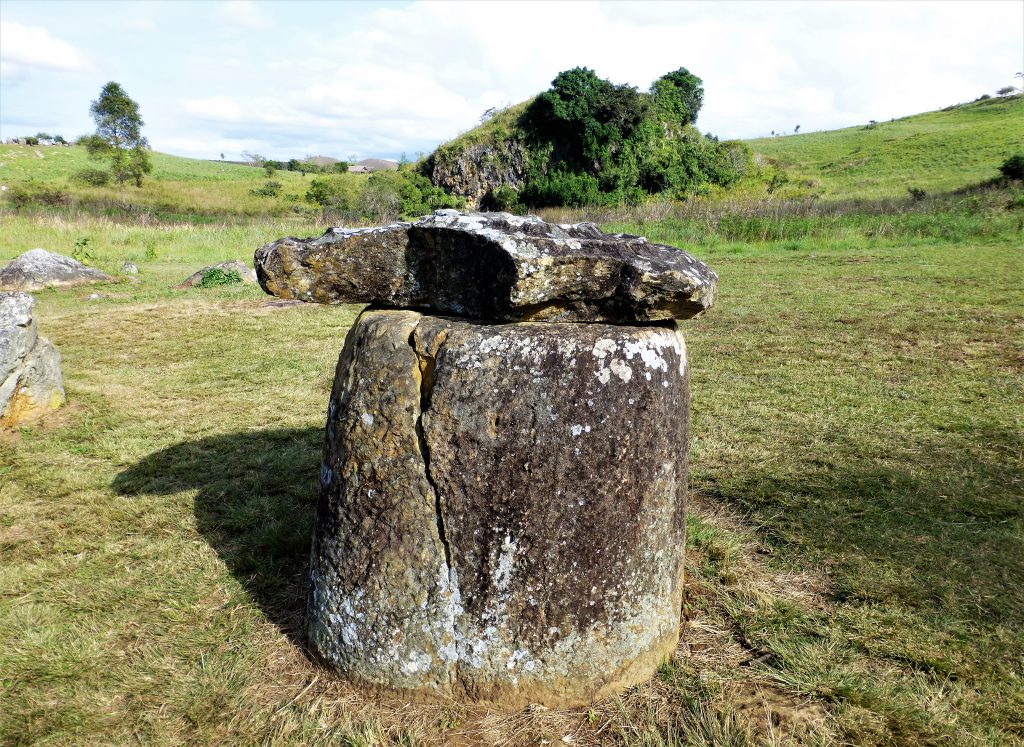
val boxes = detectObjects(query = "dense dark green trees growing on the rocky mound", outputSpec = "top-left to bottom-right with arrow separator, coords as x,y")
493,68 -> 752,207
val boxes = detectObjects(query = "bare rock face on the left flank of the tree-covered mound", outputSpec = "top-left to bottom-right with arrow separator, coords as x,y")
425,138 -> 528,210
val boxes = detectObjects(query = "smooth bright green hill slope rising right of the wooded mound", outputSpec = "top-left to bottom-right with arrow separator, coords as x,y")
746,95 -> 1024,198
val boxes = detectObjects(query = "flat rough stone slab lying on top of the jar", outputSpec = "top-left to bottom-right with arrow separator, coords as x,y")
255,210 -> 718,324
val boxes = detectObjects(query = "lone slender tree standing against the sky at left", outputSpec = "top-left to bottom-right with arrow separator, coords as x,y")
86,81 -> 153,190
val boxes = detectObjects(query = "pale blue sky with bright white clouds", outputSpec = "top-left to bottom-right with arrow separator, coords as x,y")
0,0 -> 1024,160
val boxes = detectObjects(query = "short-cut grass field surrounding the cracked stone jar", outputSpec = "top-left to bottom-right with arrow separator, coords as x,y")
0,211 -> 1024,745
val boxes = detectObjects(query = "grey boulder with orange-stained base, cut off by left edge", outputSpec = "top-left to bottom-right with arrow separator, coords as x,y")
0,293 -> 65,426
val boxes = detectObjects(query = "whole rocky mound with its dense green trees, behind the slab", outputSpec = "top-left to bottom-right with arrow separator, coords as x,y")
423,68 -> 751,208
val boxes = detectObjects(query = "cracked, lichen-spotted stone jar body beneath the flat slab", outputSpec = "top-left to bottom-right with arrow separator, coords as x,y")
307,310 -> 688,707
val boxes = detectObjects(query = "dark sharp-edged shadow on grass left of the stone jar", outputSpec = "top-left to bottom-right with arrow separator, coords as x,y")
113,427 -> 324,647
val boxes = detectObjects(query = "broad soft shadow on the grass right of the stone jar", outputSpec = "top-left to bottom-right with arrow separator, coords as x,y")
693,427 -> 1024,626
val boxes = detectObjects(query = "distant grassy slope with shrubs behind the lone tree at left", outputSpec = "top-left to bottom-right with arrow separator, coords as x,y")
0,146 -> 462,222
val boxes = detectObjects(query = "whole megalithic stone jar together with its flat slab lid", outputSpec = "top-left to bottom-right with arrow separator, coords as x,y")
256,211 -> 717,707
